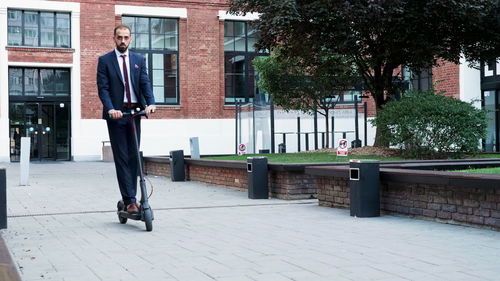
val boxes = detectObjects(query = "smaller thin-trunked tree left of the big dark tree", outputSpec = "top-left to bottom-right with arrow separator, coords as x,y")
253,49 -> 358,147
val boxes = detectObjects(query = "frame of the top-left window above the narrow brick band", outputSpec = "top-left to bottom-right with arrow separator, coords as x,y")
7,9 -> 72,49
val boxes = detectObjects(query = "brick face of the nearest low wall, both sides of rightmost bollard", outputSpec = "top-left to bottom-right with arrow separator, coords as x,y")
316,177 -> 500,229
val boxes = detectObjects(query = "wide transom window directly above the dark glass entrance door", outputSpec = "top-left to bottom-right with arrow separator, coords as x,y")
9,67 -> 71,96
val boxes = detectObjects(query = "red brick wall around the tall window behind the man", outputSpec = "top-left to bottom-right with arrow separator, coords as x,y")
72,0 -> 230,119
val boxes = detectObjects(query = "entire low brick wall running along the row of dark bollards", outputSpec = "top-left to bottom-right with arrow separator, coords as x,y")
145,157 -> 500,230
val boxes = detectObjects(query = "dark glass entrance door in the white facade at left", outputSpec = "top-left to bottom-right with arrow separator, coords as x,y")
9,102 -> 70,161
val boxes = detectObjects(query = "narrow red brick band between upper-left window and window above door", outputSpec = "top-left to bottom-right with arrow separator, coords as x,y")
6,47 -> 75,64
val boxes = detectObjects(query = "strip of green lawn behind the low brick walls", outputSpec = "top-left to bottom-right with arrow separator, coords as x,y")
203,152 -> 500,163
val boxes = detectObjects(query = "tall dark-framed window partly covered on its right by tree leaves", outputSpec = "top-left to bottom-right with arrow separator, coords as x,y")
224,21 -> 268,104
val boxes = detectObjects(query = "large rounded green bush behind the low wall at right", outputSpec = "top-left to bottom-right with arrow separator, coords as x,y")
372,91 -> 487,158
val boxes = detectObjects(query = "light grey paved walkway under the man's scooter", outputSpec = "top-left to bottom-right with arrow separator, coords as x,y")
0,162 -> 500,281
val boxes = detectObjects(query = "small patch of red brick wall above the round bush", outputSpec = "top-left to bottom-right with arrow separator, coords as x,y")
432,60 -> 460,99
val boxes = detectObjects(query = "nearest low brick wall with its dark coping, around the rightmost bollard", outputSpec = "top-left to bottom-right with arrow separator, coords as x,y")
308,168 -> 500,230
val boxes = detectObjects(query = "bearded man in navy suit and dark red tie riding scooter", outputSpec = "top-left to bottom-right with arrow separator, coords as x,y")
97,25 -> 156,213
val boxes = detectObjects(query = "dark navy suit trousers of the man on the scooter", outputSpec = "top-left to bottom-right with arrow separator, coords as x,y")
107,117 -> 141,205
